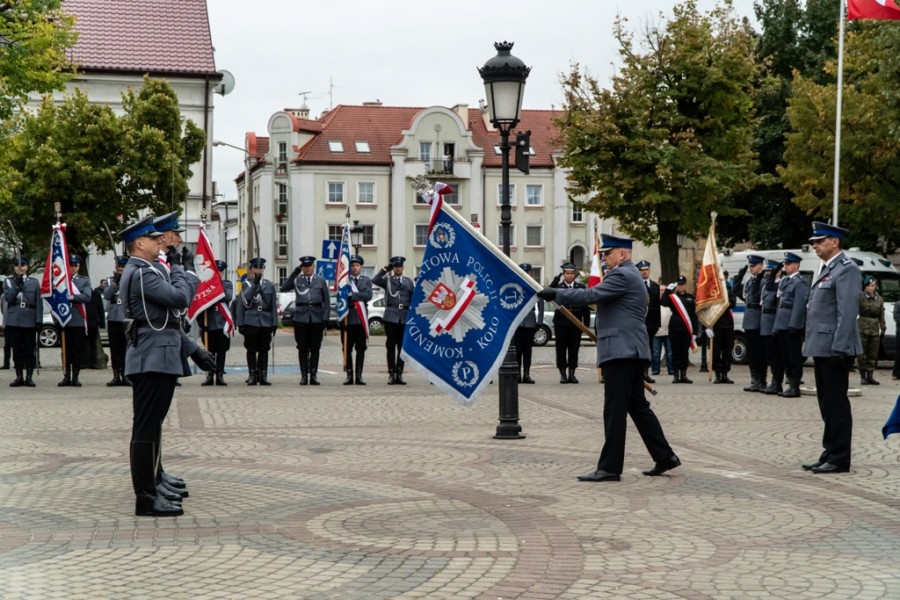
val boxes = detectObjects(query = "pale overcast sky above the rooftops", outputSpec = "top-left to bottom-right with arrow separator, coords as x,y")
207,0 -> 753,199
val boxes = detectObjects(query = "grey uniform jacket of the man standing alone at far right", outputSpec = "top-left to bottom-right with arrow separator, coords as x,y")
803,252 -> 862,358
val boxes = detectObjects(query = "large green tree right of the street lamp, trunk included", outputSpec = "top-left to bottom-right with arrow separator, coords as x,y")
557,0 -> 761,279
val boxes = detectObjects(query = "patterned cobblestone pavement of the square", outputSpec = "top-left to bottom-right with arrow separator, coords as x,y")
0,334 -> 900,600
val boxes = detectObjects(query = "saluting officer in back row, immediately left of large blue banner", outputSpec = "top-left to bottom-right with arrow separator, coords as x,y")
372,256 -> 416,385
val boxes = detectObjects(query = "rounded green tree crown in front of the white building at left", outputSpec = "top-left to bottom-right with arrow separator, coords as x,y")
0,78 -> 205,257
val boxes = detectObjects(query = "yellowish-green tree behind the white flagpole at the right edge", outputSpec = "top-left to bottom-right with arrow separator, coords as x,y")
779,22 -> 900,253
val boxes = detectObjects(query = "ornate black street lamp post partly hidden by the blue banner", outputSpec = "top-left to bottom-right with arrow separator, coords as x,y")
478,42 -> 531,439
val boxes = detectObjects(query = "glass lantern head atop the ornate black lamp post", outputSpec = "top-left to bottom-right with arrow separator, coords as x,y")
478,42 -> 531,129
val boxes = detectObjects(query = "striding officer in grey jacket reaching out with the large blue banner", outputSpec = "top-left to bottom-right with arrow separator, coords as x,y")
538,234 -> 681,481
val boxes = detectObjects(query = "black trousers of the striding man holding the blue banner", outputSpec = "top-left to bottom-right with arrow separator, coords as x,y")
597,358 -> 675,474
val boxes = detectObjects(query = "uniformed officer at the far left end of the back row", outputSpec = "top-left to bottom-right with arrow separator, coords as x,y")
3,256 -> 44,387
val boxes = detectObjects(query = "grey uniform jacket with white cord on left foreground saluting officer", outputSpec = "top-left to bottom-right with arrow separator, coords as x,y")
119,256 -> 196,376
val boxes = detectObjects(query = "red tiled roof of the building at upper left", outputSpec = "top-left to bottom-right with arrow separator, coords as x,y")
62,0 -> 216,75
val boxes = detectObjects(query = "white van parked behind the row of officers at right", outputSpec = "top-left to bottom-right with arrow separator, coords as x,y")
719,244 -> 900,364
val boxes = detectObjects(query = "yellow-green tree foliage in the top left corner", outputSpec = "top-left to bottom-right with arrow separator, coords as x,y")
0,0 -> 77,121
